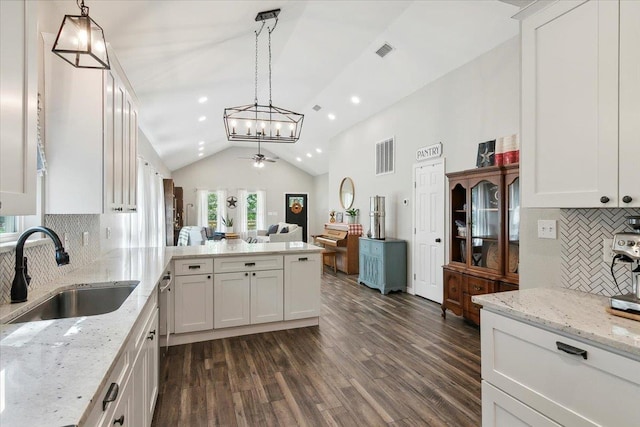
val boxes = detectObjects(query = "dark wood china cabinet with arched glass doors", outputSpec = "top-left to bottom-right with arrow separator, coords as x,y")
442,164 -> 520,324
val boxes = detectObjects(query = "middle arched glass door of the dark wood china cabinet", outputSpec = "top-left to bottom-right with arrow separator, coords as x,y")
469,180 -> 502,273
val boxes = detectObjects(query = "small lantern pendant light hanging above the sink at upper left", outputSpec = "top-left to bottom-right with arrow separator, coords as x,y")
51,0 -> 111,70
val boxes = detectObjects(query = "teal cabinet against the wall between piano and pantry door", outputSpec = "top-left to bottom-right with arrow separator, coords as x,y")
358,237 -> 407,295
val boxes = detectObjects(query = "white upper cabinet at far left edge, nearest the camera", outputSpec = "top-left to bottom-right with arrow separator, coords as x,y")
0,0 -> 38,216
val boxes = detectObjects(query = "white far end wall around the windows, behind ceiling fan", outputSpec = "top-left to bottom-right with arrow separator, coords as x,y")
172,147 -> 316,237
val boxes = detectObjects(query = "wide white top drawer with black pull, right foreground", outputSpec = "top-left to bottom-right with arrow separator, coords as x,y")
481,310 -> 640,426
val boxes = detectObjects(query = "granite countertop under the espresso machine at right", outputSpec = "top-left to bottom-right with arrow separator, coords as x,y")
472,288 -> 640,360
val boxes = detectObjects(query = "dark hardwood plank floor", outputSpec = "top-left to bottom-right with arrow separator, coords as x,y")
153,274 -> 481,427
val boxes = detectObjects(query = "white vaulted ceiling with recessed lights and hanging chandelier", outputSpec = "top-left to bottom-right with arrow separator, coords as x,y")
50,0 -> 519,175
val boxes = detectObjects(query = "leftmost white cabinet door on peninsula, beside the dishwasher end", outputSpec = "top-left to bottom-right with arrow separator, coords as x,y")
174,274 -> 213,334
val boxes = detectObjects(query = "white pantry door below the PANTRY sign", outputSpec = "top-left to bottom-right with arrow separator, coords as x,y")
412,159 -> 444,303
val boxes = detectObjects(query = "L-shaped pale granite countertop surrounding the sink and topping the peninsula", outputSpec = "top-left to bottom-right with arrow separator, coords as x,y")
0,240 -> 322,427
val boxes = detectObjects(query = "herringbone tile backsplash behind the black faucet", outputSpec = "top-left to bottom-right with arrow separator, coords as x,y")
0,215 -> 100,303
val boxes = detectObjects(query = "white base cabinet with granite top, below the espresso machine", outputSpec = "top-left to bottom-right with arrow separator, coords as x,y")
473,288 -> 640,427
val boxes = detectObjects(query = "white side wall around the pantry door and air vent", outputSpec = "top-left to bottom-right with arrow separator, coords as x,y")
327,37 -> 520,284
